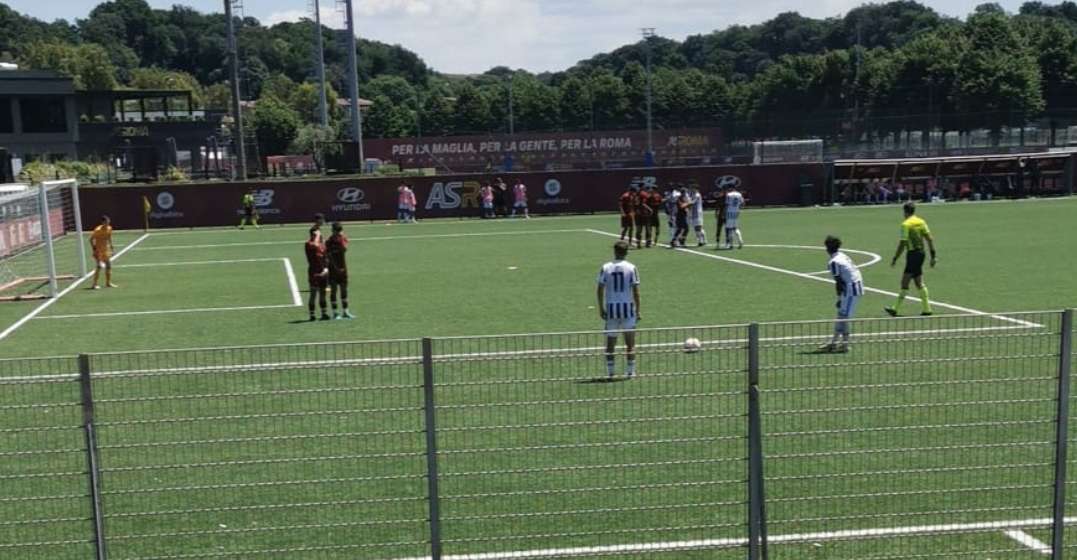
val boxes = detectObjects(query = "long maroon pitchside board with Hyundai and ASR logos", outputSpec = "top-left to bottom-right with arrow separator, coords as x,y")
81,164 -> 825,228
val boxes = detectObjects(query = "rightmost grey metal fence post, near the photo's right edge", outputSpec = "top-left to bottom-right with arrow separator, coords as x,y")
1051,309 -> 1074,560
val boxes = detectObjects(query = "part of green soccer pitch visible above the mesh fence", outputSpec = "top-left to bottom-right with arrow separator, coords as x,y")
0,199 -> 1077,356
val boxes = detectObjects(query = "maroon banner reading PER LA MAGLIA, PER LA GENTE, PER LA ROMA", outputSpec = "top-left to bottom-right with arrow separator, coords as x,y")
363,128 -> 722,171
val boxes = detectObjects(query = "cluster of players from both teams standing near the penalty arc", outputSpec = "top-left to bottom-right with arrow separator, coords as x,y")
618,184 -> 745,249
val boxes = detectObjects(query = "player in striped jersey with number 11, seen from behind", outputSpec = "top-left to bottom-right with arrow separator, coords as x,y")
598,241 -> 640,378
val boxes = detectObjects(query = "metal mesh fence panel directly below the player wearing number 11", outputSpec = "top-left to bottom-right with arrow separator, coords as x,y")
434,327 -> 746,558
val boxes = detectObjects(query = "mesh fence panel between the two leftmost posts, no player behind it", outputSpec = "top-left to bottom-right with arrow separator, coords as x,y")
86,340 -> 429,560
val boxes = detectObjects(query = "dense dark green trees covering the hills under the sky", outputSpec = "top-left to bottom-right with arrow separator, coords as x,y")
0,0 -> 1077,153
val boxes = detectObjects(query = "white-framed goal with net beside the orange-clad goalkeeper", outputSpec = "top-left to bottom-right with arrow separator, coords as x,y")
0,180 -> 86,302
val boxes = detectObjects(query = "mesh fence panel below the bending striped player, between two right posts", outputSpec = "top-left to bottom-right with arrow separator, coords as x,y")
760,313 -> 1060,559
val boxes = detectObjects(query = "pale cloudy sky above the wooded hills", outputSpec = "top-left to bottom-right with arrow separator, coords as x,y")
0,0 -> 1058,73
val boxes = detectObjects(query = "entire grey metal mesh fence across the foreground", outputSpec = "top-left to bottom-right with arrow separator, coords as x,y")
0,311 -> 1077,560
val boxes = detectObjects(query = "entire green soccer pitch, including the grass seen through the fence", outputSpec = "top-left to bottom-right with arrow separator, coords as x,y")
0,199 -> 1077,560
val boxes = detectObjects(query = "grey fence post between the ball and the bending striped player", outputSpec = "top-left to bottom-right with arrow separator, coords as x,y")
747,323 -> 767,560
